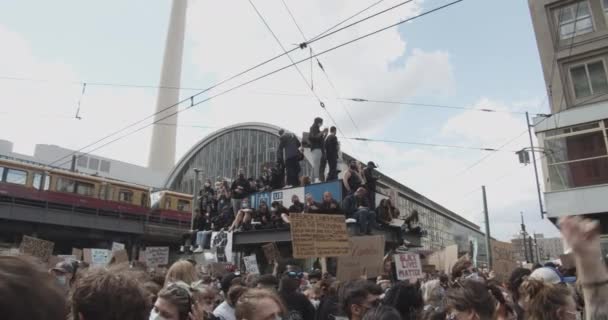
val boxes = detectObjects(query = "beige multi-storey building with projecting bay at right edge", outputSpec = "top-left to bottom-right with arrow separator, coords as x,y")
528,0 -> 608,253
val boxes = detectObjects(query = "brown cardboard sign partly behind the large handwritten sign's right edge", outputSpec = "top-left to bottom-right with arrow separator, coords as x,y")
337,236 -> 384,281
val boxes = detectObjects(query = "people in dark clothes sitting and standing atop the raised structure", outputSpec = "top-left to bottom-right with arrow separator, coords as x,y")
184,118 -> 421,251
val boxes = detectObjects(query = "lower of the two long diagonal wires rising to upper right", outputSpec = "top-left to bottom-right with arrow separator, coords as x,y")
53,0 -> 464,169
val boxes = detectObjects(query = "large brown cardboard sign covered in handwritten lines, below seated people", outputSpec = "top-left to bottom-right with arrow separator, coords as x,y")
289,213 -> 350,259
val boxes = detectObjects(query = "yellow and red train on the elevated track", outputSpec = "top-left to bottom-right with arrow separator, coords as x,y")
0,158 -> 192,226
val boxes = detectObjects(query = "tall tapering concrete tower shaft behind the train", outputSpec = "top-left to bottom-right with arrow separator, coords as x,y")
148,0 -> 188,172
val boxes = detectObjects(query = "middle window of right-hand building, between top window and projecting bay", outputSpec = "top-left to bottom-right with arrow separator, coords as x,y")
570,60 -> 608,99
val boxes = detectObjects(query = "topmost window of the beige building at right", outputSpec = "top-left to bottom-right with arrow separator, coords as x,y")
558,1 -> 593,40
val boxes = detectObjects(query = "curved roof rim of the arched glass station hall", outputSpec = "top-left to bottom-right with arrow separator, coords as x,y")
165,122 -> 289,188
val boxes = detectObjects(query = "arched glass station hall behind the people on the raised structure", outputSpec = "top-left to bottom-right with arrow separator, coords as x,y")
165,123 -> 487,263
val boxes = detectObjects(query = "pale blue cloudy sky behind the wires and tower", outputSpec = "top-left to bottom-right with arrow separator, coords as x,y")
0,0 -> 555,239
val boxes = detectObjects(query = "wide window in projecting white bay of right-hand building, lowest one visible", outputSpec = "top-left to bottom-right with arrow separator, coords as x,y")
544,121 -> 608,191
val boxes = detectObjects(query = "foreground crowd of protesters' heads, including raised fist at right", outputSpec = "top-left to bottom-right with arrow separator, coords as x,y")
0,217 -> 608,320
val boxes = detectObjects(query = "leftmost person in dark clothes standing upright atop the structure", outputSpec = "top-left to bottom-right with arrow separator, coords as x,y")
277,129 -> 304,187
